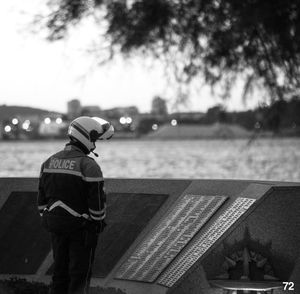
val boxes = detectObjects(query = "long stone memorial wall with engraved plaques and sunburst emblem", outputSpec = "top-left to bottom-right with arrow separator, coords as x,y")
0,178 -> 300,294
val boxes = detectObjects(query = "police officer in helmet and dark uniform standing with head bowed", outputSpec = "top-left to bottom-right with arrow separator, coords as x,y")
37,116 -> 114,294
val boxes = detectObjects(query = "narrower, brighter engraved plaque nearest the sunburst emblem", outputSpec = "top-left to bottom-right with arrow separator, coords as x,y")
158,198 -> 255,287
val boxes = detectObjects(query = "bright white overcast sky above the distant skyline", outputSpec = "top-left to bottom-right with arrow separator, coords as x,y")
0,0 -> 257,112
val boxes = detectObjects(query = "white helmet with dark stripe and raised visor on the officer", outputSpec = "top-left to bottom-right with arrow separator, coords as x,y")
68,116 -> 114,151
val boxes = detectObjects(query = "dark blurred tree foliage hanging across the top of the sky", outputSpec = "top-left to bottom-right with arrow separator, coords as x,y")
41,0 -> 300,101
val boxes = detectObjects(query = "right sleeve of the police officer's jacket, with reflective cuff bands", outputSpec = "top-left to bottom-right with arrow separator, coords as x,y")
83,159 -> 106,221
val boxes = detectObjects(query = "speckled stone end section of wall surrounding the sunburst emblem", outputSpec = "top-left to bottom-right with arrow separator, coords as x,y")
168,185 -> 300,294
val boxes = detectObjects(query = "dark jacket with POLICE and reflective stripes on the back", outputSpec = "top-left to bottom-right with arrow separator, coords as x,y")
37,144 -> 106,221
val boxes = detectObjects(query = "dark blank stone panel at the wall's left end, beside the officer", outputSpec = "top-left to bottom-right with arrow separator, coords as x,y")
0,192 -> 50,274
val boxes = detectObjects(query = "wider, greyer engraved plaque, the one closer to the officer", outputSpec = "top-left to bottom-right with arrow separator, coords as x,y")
116,195 -> 227,282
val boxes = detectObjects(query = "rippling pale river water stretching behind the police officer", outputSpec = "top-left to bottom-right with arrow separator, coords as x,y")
0,139 -> 300,182
